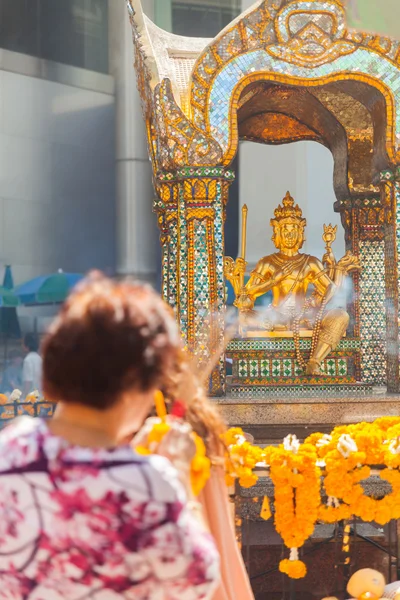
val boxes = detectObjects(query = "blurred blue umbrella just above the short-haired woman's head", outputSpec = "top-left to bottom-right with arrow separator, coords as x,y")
15,270 -> 83,304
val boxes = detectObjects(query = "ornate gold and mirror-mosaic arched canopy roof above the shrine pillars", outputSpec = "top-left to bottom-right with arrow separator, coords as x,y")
128,0 -> 400,176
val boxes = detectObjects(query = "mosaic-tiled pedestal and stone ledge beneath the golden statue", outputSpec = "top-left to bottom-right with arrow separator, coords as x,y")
222,338 -> 400,443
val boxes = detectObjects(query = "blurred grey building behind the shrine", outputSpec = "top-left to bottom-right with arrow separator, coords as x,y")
0,0 -> 340,328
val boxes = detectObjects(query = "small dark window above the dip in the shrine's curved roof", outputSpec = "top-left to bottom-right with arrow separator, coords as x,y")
172,0 -> 240,38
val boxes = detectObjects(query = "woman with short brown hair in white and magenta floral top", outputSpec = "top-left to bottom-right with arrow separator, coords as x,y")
0,274 -> 219,600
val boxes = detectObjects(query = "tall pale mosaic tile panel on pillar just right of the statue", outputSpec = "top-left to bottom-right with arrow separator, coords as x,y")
359,241 -> 386,384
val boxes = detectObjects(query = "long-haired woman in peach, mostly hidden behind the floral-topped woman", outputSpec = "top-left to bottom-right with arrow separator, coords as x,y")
138,352 -> 254,600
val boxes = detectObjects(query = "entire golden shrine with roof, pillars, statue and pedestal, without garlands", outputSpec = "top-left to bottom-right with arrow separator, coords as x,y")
128,0 -> 400,440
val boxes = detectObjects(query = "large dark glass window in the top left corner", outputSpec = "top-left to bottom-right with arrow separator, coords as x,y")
0,0 -> 108,73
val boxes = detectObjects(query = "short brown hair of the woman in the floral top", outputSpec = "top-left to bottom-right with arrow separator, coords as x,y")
43,273 -> 181,410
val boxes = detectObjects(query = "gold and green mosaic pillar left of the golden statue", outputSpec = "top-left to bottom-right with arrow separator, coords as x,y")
156,167 -> 234,396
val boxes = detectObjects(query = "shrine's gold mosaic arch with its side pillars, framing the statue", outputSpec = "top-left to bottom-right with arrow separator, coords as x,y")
129,0 -> 400,394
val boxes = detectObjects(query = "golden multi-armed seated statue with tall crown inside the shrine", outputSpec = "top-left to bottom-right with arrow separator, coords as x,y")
225,192 -> 360,375
